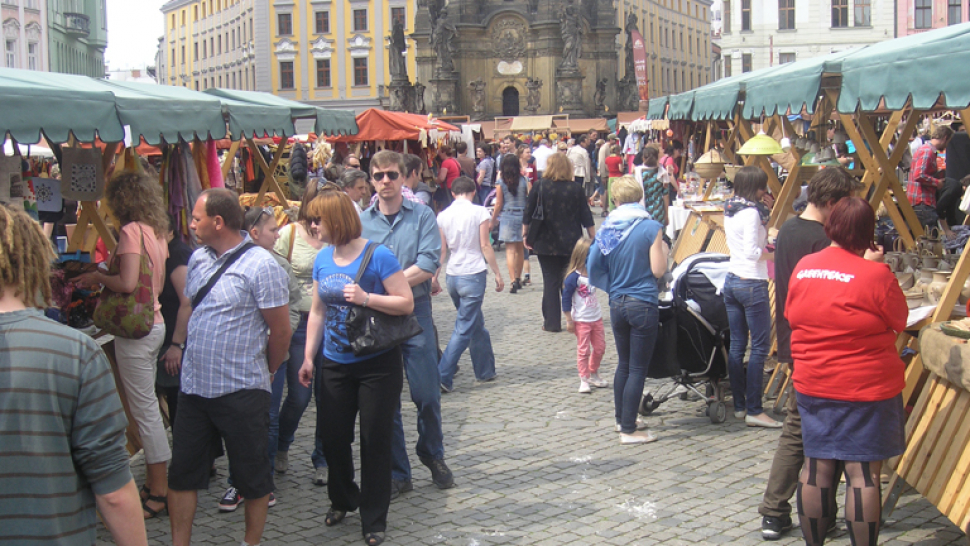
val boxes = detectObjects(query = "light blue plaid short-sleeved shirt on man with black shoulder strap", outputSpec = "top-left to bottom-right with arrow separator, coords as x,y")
182,235 -> 289,398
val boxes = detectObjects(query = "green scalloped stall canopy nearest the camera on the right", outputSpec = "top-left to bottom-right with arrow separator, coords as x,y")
838,23 -> 970,114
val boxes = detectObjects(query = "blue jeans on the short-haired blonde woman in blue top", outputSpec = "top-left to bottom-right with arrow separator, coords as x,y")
610,296 -> 660,434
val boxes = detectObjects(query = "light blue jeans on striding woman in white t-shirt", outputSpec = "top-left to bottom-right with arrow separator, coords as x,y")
438,271 -> 495,389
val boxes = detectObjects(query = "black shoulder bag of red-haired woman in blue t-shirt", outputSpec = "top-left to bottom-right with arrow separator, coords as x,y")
346,242 -> 424,356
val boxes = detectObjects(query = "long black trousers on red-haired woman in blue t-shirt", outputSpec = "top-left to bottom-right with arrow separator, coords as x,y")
317,347 -> 404,534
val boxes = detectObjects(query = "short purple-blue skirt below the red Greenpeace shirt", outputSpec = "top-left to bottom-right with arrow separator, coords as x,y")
796,393 -> 906,461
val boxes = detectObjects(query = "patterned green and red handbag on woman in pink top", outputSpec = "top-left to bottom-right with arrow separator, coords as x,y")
93,224 -> 155,339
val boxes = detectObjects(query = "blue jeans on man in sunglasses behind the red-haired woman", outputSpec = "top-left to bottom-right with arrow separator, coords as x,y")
391,296 -> 445,481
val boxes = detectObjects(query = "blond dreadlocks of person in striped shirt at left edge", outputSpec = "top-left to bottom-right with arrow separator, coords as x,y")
0,205 -> 55,307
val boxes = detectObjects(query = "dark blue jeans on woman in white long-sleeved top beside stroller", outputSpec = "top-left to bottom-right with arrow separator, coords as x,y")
724,273 -> 771,415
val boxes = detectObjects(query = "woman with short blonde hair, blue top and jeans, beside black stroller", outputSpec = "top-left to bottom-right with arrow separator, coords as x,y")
586,176 -> 667,445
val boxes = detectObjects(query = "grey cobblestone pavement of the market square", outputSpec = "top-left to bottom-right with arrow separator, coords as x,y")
108,243 -> 963,546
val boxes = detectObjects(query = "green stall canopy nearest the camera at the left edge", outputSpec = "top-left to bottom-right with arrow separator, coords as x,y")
0,68 -> 125,144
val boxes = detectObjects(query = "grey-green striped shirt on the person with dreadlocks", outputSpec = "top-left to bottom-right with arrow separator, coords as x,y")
0,309 -> 131,546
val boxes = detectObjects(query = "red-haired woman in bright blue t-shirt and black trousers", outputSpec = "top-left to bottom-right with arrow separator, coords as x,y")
300,189 -> 414,546
